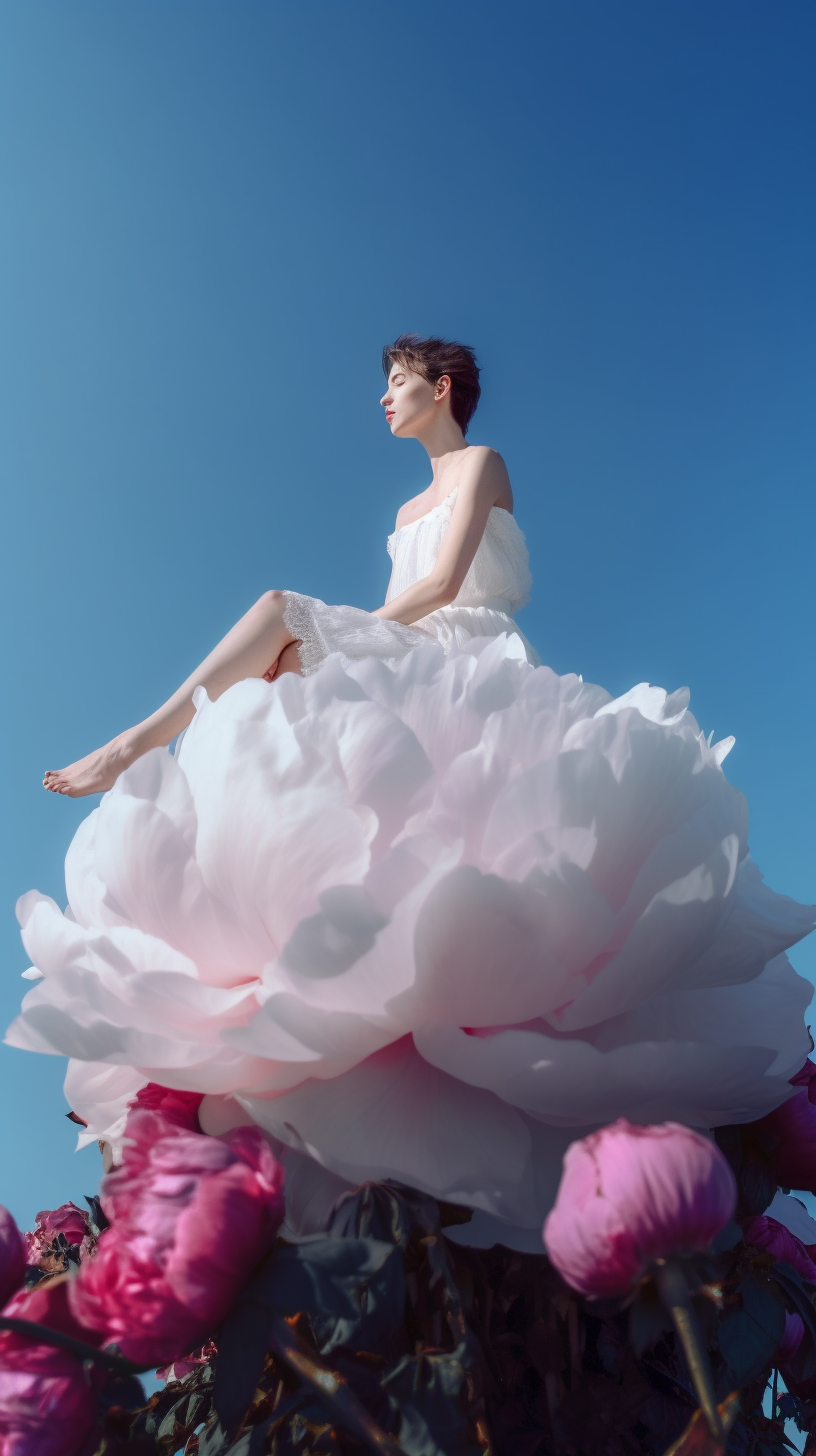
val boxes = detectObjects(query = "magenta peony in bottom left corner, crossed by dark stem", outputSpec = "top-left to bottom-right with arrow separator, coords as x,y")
0,1278 -> 106,1456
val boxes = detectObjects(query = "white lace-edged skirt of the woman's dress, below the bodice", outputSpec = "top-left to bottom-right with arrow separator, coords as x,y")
284,591 -> 541,677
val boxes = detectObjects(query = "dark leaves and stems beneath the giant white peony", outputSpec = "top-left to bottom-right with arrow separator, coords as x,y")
62,1185 -> 816,1456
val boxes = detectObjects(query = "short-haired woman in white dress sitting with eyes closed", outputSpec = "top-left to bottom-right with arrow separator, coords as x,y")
42,333 -> 538,798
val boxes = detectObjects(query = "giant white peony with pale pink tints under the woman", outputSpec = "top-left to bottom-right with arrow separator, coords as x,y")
7,638 -> 812,1245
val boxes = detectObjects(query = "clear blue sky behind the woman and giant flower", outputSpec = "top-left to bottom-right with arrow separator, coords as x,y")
0,0 -> 816,1219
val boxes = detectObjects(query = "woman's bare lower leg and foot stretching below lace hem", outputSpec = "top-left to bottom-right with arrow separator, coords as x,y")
42,591 -> 297,798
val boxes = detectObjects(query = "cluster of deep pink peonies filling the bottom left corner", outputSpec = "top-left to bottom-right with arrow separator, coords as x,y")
0,1086 -> 283,1456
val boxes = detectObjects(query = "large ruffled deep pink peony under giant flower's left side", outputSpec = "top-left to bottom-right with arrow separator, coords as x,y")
71,1109 -> 283,1364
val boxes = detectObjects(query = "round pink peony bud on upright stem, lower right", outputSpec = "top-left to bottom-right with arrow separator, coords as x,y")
544,1118 -> 736,1299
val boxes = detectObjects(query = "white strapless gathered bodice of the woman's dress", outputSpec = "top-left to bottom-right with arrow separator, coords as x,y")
386,489 -> 532,614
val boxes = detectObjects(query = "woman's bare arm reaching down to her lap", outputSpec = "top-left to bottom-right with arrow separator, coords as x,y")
374,446 -> 513,626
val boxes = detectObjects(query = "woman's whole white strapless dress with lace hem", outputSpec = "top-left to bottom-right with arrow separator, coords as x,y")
284,491 -> 539,677
